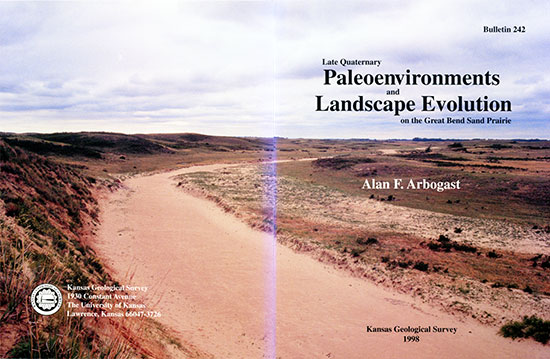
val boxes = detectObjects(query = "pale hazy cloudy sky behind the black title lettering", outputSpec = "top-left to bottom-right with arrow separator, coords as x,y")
0,1 -> 550,138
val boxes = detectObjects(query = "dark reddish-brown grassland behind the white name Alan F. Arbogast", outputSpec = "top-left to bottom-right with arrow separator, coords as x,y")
279,141 -> 550,226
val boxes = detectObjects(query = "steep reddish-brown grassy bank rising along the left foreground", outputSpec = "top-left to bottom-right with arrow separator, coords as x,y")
0,141 -> 208,359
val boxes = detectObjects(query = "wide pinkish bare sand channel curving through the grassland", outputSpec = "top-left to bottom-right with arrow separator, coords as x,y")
94,165 -> 549,359
